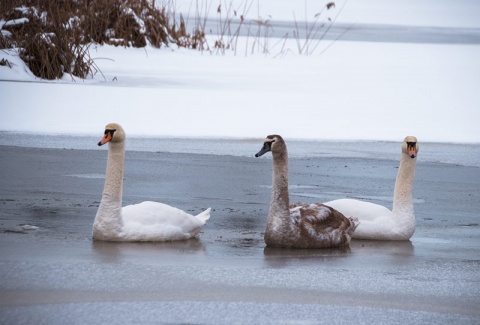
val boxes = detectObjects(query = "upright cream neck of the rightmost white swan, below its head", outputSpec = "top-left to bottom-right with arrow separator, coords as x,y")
392,154 -> 416,218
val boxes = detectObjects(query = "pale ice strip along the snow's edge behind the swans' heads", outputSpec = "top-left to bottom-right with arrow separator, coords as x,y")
0,131 -> 480,167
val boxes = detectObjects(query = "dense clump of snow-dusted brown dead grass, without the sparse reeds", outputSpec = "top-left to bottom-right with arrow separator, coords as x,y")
0,0 -> 205,80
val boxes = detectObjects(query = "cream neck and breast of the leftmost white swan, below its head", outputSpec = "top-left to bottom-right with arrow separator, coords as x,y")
94,142 -> 125,239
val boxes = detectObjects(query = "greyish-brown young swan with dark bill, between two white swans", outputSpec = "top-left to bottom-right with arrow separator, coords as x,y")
255,135 -> 357,248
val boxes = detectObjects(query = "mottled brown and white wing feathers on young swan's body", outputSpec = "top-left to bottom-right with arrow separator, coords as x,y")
289,202 -> 357,248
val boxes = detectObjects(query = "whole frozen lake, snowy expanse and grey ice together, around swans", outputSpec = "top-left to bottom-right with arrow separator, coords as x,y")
0,0 -> 480,325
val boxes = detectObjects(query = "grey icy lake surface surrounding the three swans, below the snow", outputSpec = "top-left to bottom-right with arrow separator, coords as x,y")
0,144 -> 480,325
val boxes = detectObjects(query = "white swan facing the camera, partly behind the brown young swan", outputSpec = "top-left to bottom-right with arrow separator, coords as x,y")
325,136 -> 419,240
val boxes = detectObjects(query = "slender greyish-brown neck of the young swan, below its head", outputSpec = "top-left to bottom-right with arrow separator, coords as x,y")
269,149 -> 290,222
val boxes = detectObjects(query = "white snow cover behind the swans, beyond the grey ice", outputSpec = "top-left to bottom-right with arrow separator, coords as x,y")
0,0 -> 480,143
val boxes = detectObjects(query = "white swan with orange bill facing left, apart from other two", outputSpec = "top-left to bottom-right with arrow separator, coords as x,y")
93,123 -> 210,241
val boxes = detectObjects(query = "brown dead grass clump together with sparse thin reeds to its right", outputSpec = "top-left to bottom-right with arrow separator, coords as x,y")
0,0 -> 346,79
